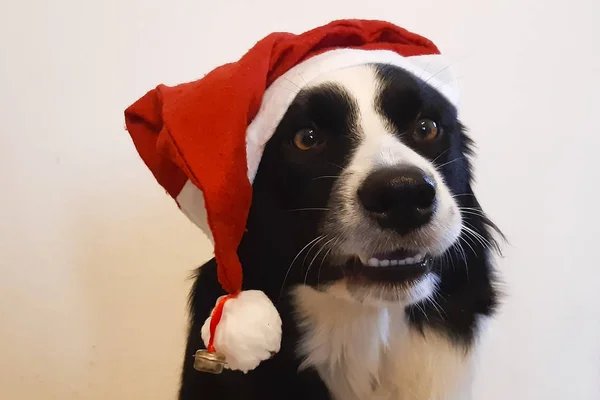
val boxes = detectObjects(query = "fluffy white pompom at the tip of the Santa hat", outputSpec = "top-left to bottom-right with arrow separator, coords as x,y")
202,290 -> 281,373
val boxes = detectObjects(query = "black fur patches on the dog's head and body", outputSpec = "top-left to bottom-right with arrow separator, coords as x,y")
180,66 -> 496,400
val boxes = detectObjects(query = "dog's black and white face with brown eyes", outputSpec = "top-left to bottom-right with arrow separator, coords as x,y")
248,65 -> 474,304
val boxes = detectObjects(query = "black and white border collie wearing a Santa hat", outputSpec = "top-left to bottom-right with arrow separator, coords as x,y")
180,61 -> 497,400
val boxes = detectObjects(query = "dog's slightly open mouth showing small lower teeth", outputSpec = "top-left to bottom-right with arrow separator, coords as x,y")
348,249 -> 432,285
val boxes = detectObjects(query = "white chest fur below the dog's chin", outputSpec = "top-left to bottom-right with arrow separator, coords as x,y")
295,287 -> 472,400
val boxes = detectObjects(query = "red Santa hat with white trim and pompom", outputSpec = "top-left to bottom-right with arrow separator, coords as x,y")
125,20 -> 458,372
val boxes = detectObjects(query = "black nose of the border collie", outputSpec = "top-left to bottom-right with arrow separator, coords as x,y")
358,167 -> 436,235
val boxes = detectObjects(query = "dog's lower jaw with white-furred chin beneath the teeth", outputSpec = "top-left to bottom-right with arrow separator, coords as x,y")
327,256 -> 439,306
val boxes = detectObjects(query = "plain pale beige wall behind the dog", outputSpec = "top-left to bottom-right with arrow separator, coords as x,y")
0,0 -> 600,400
